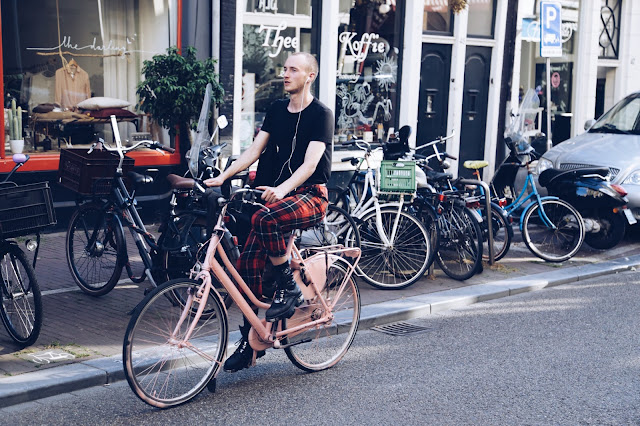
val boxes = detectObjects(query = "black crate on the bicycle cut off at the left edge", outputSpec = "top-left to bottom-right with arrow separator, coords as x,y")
0,182 -> 56,238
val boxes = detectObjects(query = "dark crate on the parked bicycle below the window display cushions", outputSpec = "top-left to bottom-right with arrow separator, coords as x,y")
58,148 -> 134,195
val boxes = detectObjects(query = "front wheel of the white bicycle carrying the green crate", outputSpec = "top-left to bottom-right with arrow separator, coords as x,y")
357,207 -> 432,289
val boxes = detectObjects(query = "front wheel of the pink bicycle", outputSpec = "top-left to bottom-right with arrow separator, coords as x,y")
122,279 -> 228,408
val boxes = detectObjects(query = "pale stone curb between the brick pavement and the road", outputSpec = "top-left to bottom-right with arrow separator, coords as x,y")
0,255 -> 640,408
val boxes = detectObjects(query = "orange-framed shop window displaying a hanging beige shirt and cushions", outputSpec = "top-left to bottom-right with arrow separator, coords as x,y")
2,0 -> 170,153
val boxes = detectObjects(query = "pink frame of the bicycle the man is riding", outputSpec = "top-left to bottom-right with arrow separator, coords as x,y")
179,193 -> 360,348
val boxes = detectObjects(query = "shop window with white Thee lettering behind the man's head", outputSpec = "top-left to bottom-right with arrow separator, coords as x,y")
240,0 -> 317,150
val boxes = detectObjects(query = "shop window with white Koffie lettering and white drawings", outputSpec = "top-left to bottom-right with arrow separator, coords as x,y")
335,0 -> 402,142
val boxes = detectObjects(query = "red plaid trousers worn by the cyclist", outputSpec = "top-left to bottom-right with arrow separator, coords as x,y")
237,185 -> 329,296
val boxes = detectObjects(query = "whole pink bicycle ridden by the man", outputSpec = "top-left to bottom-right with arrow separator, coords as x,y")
123,189 -> 360,408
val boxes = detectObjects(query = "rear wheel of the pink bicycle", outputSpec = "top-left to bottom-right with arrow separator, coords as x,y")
282,261 -> 360,372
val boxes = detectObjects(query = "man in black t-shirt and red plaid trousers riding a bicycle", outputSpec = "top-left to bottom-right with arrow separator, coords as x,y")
204,52 -> 334,372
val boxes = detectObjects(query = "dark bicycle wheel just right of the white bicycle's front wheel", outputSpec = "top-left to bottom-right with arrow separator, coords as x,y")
436,203 -> 482,281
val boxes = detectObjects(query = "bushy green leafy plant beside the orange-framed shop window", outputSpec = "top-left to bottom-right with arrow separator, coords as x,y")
136,46 -> 224,135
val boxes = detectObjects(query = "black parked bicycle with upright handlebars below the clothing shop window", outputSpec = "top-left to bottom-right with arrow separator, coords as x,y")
60,116 -> 174,296
